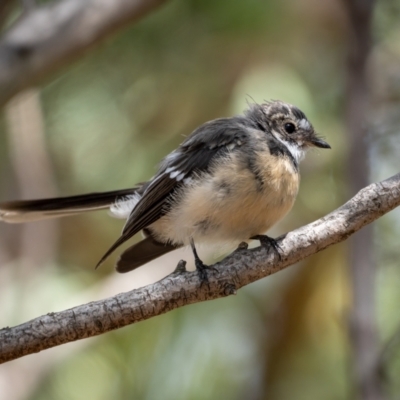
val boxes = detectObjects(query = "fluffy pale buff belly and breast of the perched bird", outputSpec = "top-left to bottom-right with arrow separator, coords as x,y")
150,155 -> 299,244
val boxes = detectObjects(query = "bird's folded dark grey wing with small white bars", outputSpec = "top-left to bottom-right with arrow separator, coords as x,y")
97,117 -> 249,266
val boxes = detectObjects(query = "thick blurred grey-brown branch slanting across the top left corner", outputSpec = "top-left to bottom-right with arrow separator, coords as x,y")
0,0 -> 170,105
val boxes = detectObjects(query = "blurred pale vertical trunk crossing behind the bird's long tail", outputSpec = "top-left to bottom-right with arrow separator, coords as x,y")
4,89 -> 59,268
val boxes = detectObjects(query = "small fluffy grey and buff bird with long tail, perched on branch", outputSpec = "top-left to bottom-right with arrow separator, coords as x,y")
0,101 -> 330,277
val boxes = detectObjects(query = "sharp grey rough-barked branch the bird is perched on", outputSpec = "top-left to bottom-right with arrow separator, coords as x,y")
0,173 -> 400,362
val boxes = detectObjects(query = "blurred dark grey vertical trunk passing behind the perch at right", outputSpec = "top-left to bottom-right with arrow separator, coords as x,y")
344,0 -> 384,400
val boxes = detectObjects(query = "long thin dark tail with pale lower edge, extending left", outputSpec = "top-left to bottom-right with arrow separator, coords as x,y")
0,188 -> 137,223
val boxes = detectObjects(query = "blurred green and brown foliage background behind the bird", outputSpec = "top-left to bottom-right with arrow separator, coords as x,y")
0,0 -> 400,400
